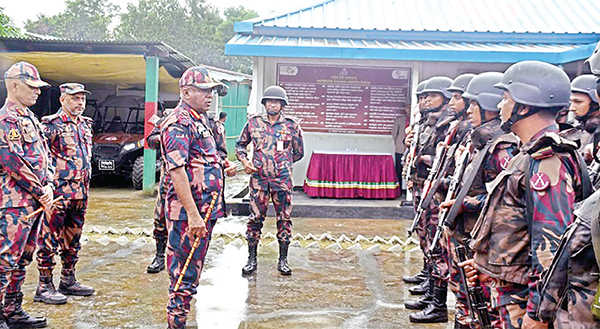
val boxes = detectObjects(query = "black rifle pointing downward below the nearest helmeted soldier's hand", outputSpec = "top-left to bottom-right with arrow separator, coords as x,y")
455,241 -> 493,329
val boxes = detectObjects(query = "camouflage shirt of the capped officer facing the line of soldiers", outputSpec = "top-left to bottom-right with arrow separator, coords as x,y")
160,102 -> 223,220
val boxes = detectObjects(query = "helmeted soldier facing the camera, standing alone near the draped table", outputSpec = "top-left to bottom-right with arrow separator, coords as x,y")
235,86 -> 304,275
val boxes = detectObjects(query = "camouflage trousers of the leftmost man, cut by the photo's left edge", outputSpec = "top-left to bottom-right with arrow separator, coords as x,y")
0,206 -> 44,301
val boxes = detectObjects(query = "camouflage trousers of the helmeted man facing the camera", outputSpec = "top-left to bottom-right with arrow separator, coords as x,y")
246,189 -> 292,245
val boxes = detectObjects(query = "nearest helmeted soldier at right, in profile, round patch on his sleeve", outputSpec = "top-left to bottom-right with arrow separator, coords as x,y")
461,61 -> 591,328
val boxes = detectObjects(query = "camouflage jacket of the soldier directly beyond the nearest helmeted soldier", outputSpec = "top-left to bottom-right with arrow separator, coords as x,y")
458,118 -> 519,233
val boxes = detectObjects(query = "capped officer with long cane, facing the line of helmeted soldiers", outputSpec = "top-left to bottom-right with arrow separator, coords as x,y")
160,67 -> 235,328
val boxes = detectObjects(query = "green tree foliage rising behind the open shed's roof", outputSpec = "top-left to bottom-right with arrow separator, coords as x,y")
20,0 -> 258,73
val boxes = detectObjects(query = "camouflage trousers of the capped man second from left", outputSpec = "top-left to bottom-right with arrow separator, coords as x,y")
37,199 -> 87,272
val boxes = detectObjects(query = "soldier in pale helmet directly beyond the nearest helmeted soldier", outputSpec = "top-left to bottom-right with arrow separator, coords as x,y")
440,72 -> 518,328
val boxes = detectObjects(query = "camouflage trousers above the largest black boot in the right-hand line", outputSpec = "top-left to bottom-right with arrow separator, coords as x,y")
426,198 -> 450,286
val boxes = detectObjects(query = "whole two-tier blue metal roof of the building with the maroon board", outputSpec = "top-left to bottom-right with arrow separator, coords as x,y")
225,0 -> 600,64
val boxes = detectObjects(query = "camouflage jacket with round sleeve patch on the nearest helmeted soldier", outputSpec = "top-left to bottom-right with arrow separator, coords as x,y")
471,125 -> 583,319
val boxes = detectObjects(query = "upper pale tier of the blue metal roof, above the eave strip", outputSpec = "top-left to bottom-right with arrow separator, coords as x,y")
245,0 -> 600,33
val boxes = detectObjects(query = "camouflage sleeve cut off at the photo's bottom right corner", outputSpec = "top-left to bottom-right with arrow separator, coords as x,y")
538,191 -> 600,328
